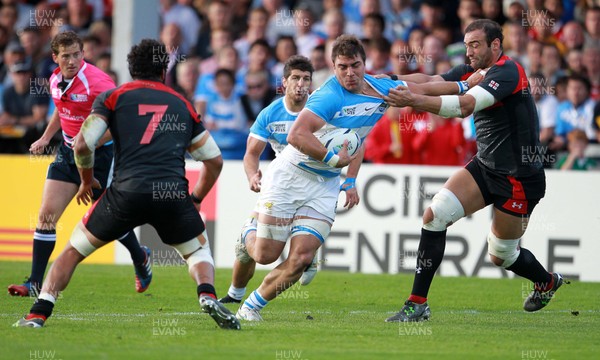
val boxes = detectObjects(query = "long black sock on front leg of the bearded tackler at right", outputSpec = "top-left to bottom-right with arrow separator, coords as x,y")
408,229 -> 446,304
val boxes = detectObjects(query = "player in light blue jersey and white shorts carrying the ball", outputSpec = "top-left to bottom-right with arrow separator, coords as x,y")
236,35 -> 478,321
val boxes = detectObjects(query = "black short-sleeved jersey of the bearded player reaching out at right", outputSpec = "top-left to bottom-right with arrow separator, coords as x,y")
442,55 -> 543,176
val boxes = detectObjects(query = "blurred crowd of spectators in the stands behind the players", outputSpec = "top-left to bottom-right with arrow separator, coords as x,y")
0,0 -> 600,169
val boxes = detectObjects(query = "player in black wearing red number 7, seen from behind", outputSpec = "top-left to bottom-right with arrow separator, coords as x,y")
15,39 -> 240,329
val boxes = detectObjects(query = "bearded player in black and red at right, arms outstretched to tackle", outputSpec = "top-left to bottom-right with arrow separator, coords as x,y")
385,19 -> 564,322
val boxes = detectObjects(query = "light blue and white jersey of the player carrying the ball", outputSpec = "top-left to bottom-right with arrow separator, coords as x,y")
281,75 -> 406,178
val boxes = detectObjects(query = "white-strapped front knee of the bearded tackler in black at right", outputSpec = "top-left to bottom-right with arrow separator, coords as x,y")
423,188 -> 465,231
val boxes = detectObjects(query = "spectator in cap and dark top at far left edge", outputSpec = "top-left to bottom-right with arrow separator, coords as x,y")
0,62 -> 49,154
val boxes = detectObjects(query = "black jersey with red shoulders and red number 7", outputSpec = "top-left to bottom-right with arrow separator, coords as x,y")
92,80 -> 205,193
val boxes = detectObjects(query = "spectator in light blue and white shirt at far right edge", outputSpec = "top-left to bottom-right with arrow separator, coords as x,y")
551,75 -> 599,150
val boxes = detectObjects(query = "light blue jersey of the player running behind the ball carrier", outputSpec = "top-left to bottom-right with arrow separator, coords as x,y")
250,98 -> 298,155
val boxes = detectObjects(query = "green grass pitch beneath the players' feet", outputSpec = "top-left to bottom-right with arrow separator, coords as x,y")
0,262 -> 600,360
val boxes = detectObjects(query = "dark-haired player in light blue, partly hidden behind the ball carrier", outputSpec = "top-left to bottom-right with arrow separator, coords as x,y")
219,56 -> 316,303
